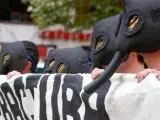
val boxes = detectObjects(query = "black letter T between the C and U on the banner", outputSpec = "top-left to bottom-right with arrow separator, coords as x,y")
26,75 -> 41,99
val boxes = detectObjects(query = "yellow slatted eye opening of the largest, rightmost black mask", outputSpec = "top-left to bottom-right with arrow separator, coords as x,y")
128,15 -> 139,31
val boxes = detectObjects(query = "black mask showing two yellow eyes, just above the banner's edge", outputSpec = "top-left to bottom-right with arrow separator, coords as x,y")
44,47 -> 90,74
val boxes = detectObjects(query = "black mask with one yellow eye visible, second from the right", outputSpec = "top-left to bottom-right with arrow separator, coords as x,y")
90,14 -> 120,69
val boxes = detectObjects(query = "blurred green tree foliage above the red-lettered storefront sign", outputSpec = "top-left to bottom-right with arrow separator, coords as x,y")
28,0 -> 122,29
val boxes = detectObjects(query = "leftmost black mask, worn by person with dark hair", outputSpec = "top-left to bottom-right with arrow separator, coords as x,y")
0,41 -> 28,74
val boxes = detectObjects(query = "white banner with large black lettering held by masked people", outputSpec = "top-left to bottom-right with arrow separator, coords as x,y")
0,74 -> 160,120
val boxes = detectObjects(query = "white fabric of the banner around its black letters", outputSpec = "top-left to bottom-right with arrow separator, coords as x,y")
0,74 -> 160,120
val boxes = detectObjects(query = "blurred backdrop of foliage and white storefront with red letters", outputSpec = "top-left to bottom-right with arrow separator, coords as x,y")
0,0 -> 123,71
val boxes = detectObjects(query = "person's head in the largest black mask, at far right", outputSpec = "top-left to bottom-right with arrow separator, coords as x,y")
108,0 -> 160,75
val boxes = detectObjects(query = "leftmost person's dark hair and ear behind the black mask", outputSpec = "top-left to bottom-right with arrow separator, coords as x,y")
21,41 -> 39,74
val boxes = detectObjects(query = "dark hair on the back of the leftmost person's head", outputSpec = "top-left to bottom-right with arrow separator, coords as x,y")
21,41 -> 39,72
